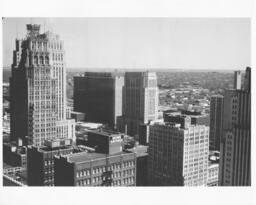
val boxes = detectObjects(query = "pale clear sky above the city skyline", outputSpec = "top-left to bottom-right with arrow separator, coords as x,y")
3,18 -> 251,70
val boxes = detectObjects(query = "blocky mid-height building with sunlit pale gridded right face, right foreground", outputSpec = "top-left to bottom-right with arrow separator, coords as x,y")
148,116 -> 209,186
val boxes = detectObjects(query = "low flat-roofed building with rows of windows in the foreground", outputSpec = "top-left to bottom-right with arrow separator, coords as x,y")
54,152 -> 136,186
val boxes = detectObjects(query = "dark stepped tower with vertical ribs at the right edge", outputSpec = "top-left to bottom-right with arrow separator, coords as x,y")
219,67 -> 251,186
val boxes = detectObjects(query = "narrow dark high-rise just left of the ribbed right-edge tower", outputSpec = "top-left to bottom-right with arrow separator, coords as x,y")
210,95 -> 224,150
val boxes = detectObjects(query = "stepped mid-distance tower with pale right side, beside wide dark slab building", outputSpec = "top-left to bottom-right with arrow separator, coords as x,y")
118,72 -> 158,136
